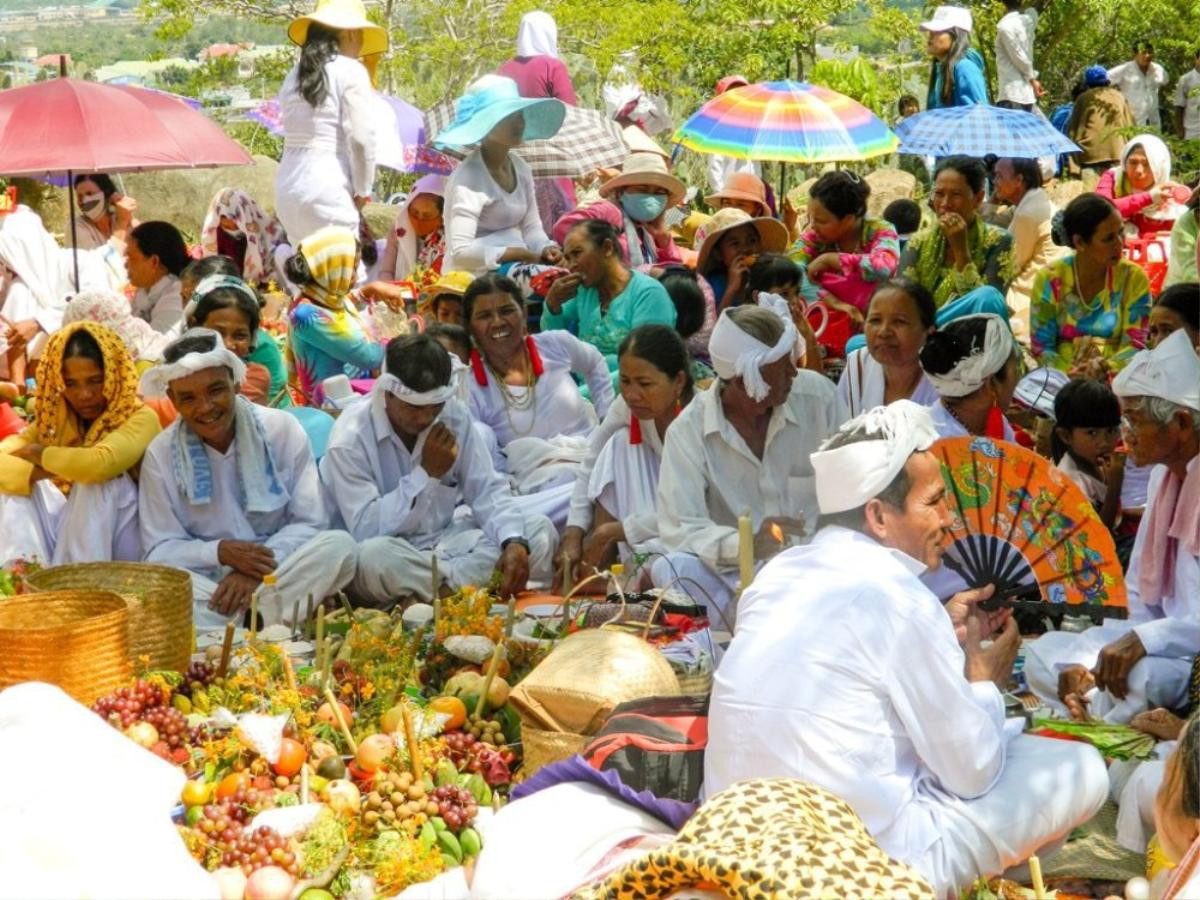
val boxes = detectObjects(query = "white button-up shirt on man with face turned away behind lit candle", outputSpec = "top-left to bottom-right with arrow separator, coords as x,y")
656,370 -> 838,570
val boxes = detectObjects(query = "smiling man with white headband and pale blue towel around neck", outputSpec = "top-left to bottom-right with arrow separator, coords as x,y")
138,328 -> 358,630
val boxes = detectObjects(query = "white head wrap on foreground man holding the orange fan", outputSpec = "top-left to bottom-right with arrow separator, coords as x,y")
809,400 -> 937,515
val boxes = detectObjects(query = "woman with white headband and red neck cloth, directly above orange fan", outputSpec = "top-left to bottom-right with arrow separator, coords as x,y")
920,313 -> 1021,440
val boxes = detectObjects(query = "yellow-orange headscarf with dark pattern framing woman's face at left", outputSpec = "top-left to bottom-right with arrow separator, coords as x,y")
37,322 -> 144,446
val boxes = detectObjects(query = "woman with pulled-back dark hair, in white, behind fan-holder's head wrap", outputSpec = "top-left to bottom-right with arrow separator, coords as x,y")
838,278 -> 937,421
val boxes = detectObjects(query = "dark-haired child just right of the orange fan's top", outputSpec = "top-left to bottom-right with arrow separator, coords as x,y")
1051,378 -> 1126,530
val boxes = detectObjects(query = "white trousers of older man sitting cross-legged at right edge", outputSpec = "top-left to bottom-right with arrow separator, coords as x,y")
1025,624 -> 1192,724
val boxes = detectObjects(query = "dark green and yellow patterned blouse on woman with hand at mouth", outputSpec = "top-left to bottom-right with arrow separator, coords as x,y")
898,216 -> 1013,308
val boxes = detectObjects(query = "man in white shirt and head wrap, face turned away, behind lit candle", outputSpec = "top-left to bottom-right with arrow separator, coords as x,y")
650,294 -> 838,631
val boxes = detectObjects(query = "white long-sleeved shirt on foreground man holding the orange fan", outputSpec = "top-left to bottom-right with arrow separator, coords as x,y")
710,528 -> 1007,860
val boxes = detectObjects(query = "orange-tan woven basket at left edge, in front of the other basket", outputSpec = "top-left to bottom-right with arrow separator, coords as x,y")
0,590 -> 133,704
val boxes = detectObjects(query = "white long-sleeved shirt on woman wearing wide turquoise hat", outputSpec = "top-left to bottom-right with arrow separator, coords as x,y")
442,150 -> 553,275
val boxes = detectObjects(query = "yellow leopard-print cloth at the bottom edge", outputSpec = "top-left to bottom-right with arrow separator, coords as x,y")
572,778 -> 934,900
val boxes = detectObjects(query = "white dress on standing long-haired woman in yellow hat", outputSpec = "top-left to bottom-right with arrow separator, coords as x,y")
275,55 -> 376,245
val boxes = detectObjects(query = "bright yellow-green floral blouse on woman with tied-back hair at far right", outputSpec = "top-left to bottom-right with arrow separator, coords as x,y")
1030,253 -> 1151,371
